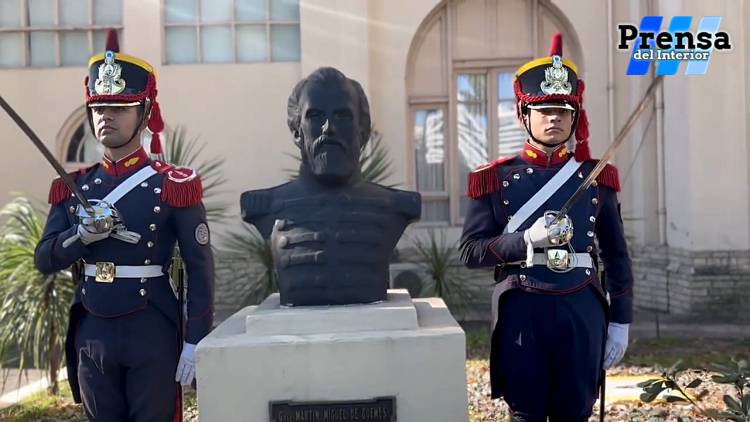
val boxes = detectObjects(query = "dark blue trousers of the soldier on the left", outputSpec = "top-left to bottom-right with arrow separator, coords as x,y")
76,306 -> 178,422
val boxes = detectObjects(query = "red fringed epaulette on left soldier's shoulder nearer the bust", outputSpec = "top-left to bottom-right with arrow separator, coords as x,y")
151,160 -> 203,208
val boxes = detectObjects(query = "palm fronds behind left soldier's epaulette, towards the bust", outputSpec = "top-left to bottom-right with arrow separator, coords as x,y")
163,126 -> 227,222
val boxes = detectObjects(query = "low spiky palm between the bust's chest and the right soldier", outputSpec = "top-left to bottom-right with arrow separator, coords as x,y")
412,229 -> 476,311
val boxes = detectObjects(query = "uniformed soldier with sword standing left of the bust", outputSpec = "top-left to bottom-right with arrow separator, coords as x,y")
35,33 -> 214,422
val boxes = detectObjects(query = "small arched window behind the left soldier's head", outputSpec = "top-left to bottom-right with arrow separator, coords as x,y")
58,106 -> 157,169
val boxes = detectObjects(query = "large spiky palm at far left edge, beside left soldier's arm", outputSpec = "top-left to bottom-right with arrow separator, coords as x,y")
0,197 -> 74,394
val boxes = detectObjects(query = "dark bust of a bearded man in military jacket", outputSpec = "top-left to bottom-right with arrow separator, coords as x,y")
240,67 -> 421,306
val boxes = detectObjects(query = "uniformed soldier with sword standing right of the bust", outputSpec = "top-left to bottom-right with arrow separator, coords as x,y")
460,34 -> 632,422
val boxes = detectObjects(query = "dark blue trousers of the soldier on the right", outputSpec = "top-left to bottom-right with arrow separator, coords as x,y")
490,287 -> 606,422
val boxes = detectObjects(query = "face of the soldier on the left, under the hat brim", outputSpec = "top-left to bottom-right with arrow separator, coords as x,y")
91,106 -> 140,148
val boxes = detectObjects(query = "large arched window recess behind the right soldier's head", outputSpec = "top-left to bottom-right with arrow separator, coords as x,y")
406,0 -> 583,224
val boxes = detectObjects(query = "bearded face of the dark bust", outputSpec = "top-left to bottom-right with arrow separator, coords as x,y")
295,81 -> 362,184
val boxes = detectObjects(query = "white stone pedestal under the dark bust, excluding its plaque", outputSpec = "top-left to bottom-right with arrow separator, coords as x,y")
197,290 -> 467,422
